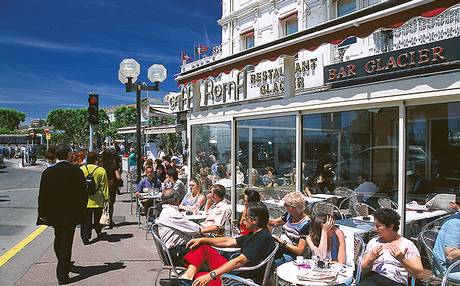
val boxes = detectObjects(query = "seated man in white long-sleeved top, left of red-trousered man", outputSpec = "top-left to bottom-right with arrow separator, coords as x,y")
155,189 -> 200,265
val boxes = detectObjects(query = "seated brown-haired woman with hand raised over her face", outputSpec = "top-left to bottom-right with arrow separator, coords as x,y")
307,214 -> 347,263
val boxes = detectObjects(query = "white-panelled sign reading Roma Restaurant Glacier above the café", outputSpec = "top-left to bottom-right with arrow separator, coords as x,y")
165,58 -> 322,111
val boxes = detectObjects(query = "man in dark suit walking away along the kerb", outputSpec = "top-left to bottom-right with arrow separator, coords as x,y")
37,144 -> 88,285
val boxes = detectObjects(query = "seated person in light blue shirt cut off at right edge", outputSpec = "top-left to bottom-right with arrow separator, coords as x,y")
433,208 -> 460,282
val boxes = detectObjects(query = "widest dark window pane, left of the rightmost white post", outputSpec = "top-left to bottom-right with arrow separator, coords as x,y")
301,107 -> 398,212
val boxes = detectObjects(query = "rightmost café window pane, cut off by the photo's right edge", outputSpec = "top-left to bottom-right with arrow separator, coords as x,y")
405,102 -> 460,241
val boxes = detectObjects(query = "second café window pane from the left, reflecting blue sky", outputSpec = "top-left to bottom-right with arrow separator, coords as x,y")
236,116 -> 296,216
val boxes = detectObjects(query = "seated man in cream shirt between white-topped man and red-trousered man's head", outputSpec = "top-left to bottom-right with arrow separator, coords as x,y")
200,184 -> 232,236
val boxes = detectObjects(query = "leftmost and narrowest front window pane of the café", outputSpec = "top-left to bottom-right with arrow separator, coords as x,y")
190,122 -> 232,193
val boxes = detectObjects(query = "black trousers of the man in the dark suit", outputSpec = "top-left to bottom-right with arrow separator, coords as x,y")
54,225 -> 75,281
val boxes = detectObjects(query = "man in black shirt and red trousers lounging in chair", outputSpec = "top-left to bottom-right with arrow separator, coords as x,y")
160,202 -> 275,286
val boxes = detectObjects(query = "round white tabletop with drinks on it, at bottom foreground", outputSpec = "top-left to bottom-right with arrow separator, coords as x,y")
276,262 -> 353,286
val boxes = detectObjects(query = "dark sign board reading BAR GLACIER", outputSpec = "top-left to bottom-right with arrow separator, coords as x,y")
324,37 -> 460,87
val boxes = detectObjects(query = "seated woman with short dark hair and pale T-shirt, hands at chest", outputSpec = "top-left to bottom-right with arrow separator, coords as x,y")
359,208 -> 423,286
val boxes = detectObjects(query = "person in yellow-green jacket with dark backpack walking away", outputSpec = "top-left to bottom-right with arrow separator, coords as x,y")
80,151 -> 109,245
